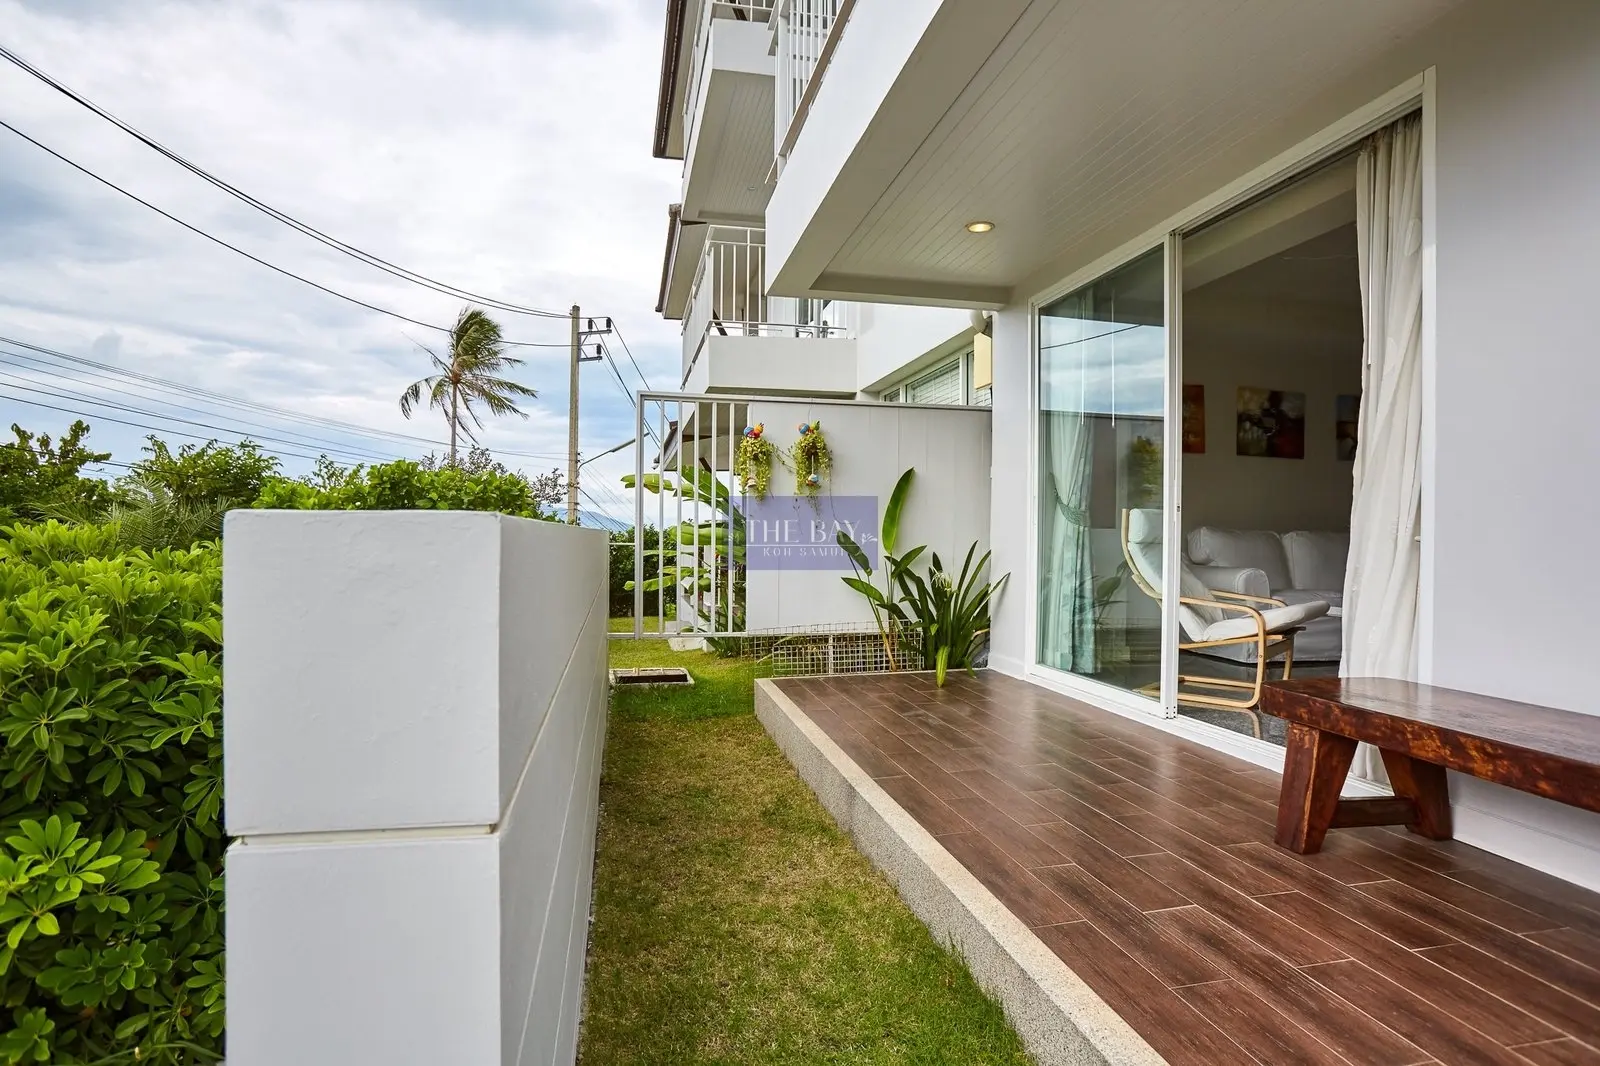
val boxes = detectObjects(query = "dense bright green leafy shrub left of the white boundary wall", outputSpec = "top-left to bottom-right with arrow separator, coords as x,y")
0,522 -> 224,1066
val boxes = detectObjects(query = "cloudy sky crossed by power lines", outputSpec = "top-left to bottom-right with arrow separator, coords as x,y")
0,0 -> 678,511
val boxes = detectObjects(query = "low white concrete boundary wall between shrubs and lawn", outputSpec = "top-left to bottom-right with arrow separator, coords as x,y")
224,511 -> 606,1066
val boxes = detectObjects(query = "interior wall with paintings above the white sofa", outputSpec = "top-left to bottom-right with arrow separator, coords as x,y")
1182,292 -> 1362,533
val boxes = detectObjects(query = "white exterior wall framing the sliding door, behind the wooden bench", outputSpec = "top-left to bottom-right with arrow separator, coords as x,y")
972,0 -> 1600,888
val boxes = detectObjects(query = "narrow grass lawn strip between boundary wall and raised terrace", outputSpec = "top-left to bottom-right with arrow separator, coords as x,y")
579,624 -> 1030,1066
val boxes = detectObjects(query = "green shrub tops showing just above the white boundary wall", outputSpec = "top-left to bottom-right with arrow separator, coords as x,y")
254,459 -> 552,519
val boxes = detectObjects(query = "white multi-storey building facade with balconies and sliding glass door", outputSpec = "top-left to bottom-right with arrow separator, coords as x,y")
656,0 -> 1600,887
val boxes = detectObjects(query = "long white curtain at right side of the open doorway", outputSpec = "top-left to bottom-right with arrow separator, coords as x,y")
1339,115 -> 1422,783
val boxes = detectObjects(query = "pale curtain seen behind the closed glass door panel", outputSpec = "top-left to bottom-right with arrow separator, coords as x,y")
1040,411 -> 1098,674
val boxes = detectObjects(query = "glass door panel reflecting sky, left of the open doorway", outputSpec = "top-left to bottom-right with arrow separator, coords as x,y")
1037,248 -> 1166,698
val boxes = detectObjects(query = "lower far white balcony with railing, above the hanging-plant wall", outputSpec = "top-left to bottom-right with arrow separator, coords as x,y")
682,226 -> 856,399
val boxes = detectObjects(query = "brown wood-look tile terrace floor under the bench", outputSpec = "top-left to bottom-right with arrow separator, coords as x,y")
774,672 -> 1600,1066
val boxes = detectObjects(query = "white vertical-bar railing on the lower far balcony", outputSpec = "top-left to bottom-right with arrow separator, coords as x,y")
683,226 -> 845,384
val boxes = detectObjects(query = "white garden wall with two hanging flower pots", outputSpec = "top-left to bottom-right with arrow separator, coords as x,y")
746,400 -> 985,631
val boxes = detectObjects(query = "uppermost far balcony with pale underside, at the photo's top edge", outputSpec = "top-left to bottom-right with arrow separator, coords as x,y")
677,0 -> 774,222
